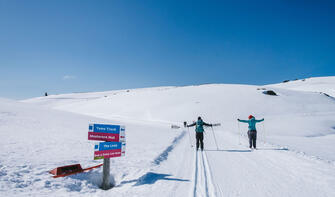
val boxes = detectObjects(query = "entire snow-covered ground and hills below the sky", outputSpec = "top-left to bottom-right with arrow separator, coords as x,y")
0,77 -> 335,197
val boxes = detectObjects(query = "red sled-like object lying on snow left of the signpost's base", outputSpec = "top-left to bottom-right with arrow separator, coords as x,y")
49,164 -> 103,178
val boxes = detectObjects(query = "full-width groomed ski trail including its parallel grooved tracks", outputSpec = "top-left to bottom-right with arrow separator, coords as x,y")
115,126 -> 335,197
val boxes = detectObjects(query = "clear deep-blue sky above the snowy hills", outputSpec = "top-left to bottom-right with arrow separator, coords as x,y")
0,0 -> 335,99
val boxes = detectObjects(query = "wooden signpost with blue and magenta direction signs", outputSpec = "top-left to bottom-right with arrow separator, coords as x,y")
88,124 -> 126,190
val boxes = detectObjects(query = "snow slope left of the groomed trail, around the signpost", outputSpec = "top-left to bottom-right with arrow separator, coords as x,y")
0,99 -> 180,196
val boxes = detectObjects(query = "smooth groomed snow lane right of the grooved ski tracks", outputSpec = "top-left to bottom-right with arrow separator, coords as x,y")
205,130 -> 335,197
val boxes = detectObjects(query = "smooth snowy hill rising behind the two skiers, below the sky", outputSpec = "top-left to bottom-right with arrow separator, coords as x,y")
25,81 -> 335,160
